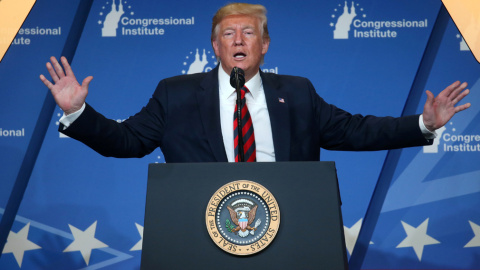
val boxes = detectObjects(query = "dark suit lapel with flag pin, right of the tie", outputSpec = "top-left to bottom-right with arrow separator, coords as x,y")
260,71 -> 290,161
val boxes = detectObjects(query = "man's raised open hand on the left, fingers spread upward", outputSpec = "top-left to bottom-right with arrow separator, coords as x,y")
40,56 -> 93,115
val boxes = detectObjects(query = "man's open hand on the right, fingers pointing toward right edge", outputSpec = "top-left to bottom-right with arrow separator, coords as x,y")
423,81 -> 470,131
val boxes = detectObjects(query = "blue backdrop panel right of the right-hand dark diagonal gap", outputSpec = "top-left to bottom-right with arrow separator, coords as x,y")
363,17 -> 480,269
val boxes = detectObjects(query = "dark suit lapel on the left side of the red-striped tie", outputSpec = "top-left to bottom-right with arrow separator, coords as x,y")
197,66 -> 228,162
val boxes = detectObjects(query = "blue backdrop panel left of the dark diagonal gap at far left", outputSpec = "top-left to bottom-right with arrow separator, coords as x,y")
0,0 -> 79,207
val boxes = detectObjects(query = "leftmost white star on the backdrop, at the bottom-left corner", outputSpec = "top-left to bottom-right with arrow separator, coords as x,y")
2,223 -> 41,268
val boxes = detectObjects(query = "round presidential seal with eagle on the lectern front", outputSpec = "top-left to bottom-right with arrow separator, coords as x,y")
205,180 -> 280,255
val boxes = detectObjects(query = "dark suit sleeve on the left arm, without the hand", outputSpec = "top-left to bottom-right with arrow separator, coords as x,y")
59,81 -> 167,158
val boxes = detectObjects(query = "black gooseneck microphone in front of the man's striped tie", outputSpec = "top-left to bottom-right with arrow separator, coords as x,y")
230,67 -> 245,162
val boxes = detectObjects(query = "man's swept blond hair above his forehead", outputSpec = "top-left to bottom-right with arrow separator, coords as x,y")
211,3 -> 270,41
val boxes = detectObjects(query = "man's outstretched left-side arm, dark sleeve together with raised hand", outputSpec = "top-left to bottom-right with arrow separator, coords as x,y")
40,57 -> 163,157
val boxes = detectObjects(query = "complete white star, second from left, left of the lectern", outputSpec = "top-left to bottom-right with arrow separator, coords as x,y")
63,221 -> 108,265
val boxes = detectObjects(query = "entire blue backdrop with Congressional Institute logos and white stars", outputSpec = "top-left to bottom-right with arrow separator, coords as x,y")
0,0 -> 480,269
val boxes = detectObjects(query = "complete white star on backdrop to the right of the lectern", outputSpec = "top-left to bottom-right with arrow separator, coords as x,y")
397,218 -> 440,261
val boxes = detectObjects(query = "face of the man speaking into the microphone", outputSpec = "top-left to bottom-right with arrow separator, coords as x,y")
212,15 -> 270,81
